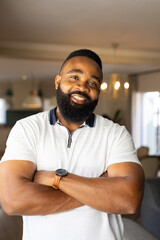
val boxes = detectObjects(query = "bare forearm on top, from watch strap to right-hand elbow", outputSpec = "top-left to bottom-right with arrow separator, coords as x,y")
60,174 -> 138,214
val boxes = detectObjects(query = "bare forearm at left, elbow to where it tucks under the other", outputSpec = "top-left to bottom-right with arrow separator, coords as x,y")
1,182 -> 83,215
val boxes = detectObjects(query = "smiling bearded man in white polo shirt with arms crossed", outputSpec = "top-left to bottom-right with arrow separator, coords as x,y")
0,49 -> 144,240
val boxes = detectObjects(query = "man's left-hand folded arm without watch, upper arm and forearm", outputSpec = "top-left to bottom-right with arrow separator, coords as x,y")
0,160 -> 83,215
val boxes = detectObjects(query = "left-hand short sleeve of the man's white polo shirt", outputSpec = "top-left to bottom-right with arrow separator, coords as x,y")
1,121 -> 36,163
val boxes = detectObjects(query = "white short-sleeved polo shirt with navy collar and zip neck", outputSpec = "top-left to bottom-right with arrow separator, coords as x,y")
2,109 -> 139,240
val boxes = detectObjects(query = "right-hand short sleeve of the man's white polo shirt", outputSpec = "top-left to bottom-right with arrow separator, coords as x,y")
106,124 -> 140,167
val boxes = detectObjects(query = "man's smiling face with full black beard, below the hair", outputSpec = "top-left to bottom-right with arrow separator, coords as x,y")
55,57 -> 102,122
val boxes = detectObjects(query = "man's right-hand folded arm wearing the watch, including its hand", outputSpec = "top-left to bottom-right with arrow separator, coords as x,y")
34,162 -> 144,214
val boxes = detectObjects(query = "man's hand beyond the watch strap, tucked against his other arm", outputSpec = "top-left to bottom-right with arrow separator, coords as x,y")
33,171 -> 55,187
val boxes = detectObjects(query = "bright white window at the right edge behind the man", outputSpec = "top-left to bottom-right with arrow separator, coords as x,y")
134,92 -> 160,156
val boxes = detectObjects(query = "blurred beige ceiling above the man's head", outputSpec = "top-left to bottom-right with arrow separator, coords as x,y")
0,0 -> 160,80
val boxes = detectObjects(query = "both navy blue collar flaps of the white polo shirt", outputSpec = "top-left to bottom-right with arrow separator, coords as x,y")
49,107 -> 95,127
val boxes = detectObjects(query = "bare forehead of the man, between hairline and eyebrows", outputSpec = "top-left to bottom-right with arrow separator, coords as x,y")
61,56 -> 102,75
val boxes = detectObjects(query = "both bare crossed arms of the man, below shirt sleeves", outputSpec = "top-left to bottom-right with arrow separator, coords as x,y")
0,160 -> 144,215
